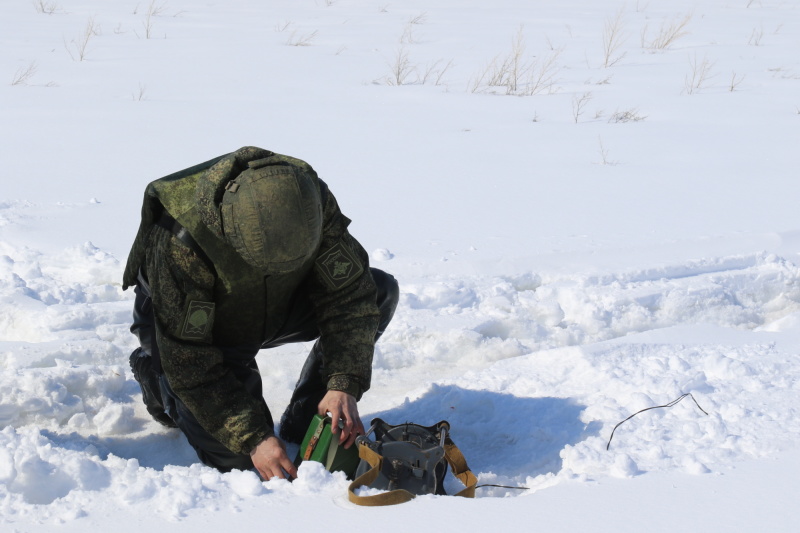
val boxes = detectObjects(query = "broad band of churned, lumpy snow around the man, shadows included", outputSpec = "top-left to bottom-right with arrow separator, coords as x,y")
0,238 -> 800,519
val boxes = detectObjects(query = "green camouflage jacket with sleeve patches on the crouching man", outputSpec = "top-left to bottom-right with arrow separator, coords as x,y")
123,148 -> 379,453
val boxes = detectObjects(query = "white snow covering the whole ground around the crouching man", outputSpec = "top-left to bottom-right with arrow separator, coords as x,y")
0,0 -> 800,533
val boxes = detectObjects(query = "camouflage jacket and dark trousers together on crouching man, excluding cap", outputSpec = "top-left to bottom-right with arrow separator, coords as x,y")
123,148 -> 398,470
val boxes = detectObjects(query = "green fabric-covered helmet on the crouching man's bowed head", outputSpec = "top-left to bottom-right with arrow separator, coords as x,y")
221,159 -> 322,274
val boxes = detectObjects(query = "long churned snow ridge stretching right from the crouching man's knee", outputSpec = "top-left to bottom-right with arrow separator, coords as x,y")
376,253 -> 800,369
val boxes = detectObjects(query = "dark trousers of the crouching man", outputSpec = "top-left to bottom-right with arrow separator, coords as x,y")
131,268 -> 399,472
